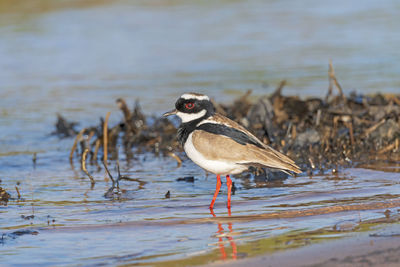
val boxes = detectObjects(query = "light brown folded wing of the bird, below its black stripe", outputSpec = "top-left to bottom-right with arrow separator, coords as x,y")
192,129 -> 301,173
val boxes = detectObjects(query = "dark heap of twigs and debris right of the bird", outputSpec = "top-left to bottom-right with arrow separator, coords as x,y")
220,87 -> 400,172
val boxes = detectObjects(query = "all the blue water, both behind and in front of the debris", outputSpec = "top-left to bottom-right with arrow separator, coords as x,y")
0,1 -> 400,265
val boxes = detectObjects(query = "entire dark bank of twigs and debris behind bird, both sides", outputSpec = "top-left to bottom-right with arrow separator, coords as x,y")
56,82 -> 400,176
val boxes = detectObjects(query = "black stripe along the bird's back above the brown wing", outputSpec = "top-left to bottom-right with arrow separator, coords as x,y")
196,123 -> 263,148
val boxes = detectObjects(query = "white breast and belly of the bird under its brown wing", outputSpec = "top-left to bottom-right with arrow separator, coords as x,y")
183,133 -> 247,175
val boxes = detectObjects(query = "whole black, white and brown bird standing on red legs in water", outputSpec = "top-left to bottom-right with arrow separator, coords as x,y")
163,93 -> 301,210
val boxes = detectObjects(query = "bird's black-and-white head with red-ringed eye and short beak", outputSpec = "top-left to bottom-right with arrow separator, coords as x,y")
163,93 -> 215,123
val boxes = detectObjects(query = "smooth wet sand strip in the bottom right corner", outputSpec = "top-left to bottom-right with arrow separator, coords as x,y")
209,224 -> 400,267
